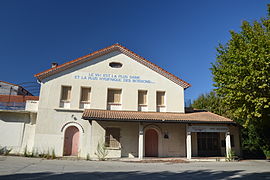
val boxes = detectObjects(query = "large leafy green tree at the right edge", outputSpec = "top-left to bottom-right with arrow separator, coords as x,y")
211,5 -> 270,155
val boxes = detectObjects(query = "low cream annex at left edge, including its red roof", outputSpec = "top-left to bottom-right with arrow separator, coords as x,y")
0,98 -> 38,153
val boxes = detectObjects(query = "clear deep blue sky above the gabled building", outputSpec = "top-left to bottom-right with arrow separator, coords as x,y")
0,0 -> 269,100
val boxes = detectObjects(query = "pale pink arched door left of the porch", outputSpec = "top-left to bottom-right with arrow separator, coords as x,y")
64,126 -> 80,156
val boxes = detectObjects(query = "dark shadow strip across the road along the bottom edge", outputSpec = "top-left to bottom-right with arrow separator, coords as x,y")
0,170 -> 270,180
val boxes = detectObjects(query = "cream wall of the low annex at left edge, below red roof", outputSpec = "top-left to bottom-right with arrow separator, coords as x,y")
0,100 -> 38,154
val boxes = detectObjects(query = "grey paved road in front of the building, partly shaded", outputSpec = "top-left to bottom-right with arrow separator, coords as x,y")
0,156 -> 270,180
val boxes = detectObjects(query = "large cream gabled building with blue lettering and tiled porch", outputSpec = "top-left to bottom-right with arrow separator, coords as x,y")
6,44 -> 240,159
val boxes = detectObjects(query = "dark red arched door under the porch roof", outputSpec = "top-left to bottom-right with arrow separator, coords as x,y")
145,129 -> 158,157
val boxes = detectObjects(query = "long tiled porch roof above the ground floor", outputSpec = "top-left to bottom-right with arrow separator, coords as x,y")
82,109 -> 235,124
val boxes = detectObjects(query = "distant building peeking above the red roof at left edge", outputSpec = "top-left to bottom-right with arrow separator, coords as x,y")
0,81 -> 33,96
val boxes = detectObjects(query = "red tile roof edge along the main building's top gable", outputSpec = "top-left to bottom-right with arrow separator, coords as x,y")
35,44 -> 191,88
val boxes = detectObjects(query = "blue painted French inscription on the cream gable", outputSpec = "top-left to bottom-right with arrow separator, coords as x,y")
74,73 -> 155,84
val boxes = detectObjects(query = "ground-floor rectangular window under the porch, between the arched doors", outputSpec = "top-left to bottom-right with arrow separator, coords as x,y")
105,128 -> 120,148
